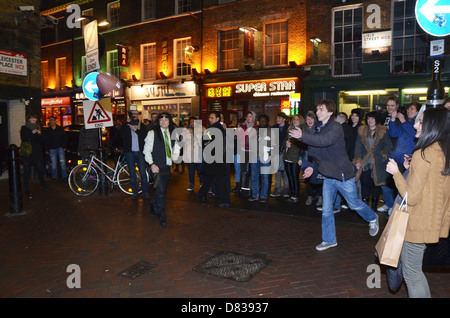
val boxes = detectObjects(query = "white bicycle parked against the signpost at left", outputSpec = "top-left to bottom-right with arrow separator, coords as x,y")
67,152 -> 148,196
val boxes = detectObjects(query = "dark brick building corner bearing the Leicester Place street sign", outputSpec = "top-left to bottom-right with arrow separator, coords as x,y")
0,0 -> 41,176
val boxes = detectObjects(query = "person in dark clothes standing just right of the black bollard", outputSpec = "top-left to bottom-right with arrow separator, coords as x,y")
20,114 -> 47,199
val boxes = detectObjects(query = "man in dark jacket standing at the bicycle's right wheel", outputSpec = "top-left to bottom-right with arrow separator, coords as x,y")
113,109 -> 150,199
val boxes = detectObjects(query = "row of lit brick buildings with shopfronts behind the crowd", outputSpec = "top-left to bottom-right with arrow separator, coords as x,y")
42,0 -> 450,129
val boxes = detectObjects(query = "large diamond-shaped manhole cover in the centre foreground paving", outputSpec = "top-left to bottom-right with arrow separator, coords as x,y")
193,251 -> 270,282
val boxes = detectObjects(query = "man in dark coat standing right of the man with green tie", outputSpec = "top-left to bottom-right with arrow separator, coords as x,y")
197,111 -> 230,208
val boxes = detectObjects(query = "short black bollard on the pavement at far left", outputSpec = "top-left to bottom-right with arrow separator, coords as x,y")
8,145 -> 23,214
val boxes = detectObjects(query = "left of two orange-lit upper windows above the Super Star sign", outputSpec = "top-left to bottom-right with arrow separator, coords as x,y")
219,29 -> 240,71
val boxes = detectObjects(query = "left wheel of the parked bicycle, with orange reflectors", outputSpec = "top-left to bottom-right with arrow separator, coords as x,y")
68,163 -> 100,197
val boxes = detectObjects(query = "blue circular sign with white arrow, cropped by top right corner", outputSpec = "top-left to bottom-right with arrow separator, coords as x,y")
416,0 -> 450,36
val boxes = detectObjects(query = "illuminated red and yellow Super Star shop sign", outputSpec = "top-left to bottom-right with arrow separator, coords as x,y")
204,78 -> 298,99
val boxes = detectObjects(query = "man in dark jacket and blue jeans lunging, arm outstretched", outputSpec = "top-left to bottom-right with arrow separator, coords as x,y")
289,100 -> 378,251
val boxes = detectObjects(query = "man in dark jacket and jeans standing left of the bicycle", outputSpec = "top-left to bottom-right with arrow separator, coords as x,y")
44,116 -> 67,180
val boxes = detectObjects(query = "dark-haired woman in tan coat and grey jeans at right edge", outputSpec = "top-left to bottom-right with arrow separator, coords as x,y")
386,108 -> 450,298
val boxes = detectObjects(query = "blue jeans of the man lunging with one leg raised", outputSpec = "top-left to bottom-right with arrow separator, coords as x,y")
322,178 -> 376,243
